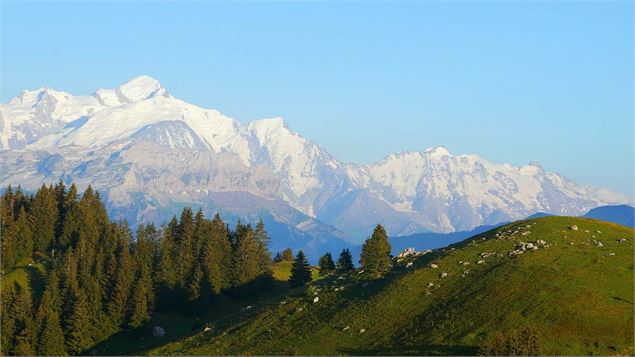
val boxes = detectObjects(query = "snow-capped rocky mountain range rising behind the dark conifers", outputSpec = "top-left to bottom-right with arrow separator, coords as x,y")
0,76 -> 629,251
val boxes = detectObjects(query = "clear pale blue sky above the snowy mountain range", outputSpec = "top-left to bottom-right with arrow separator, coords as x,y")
0,1 -> 634,195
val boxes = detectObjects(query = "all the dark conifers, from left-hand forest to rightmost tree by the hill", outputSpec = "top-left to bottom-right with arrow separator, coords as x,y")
0,181 -> 398,356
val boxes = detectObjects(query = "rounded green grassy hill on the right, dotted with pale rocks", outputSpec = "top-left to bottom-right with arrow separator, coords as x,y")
149,217 -> 634,355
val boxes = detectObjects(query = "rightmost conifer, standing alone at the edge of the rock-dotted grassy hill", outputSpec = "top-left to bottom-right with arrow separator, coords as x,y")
359,224 -> 391,278
